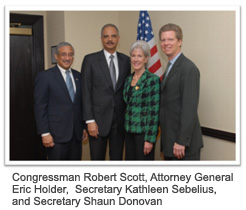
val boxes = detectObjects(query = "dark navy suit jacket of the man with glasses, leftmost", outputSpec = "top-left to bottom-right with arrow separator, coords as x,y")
34,66 -> 85,143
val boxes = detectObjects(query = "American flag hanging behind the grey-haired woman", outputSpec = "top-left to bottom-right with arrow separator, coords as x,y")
137,11 -> 163,77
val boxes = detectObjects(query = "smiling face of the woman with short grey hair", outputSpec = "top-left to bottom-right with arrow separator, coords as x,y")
131,48 -> 148,71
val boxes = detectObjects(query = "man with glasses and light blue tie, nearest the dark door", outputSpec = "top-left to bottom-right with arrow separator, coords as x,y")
34,42 -> 87,160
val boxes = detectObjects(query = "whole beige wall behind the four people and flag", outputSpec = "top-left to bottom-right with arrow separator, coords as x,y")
11,11 -> 236,160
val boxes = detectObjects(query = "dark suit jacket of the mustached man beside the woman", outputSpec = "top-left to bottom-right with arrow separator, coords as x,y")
81,50 -> 131,136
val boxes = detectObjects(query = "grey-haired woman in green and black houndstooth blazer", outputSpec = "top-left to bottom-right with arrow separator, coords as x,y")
123,41 -> 160,160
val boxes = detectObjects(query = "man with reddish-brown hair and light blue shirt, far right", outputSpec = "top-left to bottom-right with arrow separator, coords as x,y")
159,24 -> 203,160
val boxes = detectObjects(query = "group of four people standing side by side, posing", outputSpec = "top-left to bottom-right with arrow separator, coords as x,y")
35,24 -> 203,160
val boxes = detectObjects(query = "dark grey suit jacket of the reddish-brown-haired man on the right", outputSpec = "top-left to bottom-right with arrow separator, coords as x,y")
160,53 -> 203,157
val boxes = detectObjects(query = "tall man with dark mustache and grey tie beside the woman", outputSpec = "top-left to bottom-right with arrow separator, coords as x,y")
81,24 -> 131,160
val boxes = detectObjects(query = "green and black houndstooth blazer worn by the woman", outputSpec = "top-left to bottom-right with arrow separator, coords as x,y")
123,69 -> 160,143
